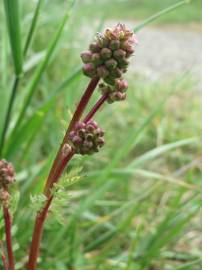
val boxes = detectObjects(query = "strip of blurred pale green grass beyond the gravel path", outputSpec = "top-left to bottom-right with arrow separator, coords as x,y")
80,0 -> 202,24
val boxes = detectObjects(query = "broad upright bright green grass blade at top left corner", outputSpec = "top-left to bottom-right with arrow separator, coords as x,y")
4,0 -> 23,76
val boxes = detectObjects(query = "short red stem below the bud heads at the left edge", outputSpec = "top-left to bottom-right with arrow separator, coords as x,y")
3,207 -> 15,270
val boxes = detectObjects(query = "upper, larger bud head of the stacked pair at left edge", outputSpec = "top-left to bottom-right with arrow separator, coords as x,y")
0,159 -> 15,188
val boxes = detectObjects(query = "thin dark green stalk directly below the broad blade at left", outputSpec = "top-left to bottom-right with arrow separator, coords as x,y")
0,77 -> 19,156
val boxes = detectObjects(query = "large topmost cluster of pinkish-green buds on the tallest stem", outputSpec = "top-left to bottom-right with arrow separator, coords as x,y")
81,24 -> 137,102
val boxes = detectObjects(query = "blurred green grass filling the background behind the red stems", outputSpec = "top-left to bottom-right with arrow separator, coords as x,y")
0,1 -> 202,270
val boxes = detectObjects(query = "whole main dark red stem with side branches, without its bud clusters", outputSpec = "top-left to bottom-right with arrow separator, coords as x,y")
27,78 -> 101,270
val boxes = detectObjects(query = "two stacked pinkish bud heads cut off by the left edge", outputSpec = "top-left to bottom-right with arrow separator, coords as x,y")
0,159 -> 15,207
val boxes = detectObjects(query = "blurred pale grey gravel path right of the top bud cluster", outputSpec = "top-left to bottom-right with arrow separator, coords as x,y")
133,27 -> 202,86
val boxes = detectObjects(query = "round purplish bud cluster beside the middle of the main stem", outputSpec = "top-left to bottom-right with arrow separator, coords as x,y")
69,120 -> 104,155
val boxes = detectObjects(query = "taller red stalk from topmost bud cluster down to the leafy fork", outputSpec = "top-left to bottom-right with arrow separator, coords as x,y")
44,78 -> 99,195
